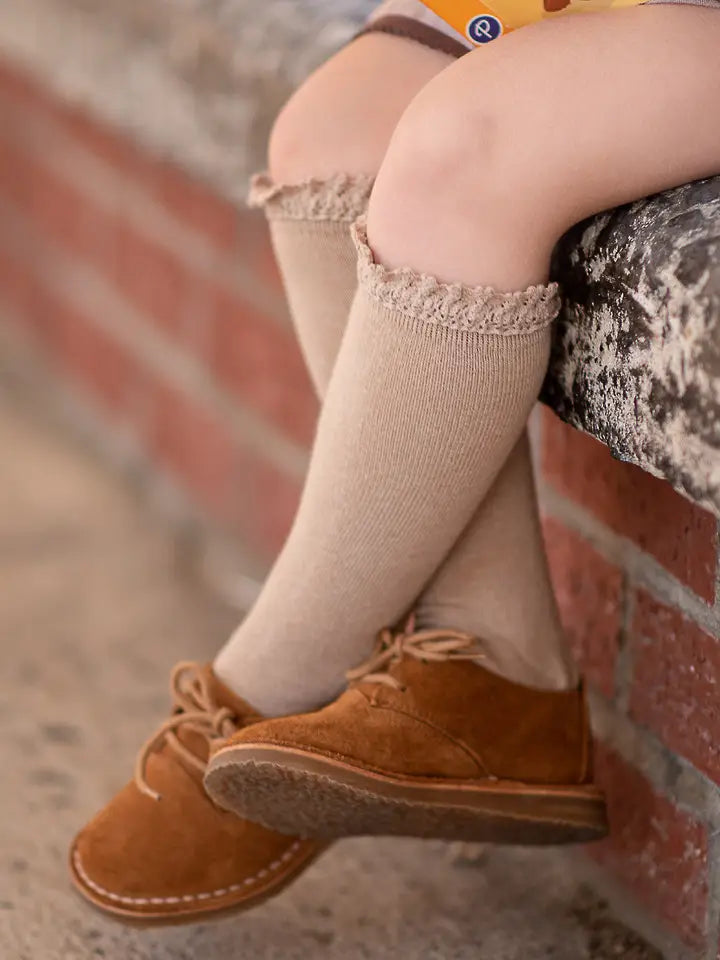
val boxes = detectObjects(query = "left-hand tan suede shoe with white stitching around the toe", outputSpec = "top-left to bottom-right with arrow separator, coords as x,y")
70,663 -> 324,924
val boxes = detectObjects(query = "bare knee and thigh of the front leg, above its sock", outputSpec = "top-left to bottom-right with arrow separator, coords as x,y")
368,5 -> 720,291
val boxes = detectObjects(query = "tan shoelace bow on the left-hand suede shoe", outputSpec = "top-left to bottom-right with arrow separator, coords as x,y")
134,662 -> 238,800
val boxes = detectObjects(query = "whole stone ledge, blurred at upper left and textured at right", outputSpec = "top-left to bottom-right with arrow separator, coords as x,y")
5,0 -> 720,515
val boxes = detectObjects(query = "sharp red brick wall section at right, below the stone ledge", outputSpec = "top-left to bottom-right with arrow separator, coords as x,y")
540,411 -> 720,960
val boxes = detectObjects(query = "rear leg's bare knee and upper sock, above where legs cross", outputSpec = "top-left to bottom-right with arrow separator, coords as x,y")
251,33 -> 452,397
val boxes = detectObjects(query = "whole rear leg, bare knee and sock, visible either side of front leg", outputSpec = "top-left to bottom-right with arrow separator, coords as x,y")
239,34 -> 573,706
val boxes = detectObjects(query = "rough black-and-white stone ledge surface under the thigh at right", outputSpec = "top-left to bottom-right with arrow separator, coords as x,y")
545,177 -> 720,513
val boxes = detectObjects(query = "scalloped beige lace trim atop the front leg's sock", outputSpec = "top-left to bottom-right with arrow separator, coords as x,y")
352,219 -> 560,336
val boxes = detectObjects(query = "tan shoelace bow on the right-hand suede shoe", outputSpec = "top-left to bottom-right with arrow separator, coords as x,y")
345,621 -> 484,690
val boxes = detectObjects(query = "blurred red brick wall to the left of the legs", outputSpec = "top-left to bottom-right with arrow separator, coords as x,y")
0,58 -> 316,562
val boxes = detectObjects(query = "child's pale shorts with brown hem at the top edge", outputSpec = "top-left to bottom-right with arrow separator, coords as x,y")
363,0 -> 720,57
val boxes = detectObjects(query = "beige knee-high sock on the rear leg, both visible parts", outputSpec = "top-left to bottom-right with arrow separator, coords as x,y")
253,174 -> 575,688
